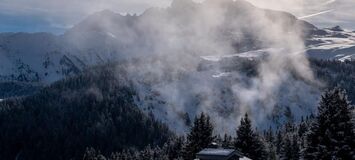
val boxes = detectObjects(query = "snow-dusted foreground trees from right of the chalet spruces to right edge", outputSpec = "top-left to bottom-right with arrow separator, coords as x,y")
263,88 -> 355,160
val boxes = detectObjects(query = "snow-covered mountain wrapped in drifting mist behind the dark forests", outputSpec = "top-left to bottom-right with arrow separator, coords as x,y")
0,0 -> 355,131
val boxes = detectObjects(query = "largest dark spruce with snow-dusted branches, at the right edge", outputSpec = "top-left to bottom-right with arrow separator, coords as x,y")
304,88 -> 355,160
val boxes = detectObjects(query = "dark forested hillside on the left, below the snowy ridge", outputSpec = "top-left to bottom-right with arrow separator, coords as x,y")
0,66 -> 172,160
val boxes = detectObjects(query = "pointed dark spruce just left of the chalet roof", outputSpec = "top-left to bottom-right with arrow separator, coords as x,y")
184,113 -> 214,159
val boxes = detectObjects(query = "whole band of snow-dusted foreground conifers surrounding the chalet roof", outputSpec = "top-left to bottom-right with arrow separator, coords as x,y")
84,88 -> 355,160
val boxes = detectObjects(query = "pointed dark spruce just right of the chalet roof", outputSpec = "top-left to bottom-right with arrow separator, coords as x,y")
234,114 -> 267,160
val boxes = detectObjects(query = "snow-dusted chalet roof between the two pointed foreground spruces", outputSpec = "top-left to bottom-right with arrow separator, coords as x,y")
196,148 -> 250,160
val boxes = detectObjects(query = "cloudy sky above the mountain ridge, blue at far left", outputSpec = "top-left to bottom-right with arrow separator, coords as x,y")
0,0 -> 355,33
